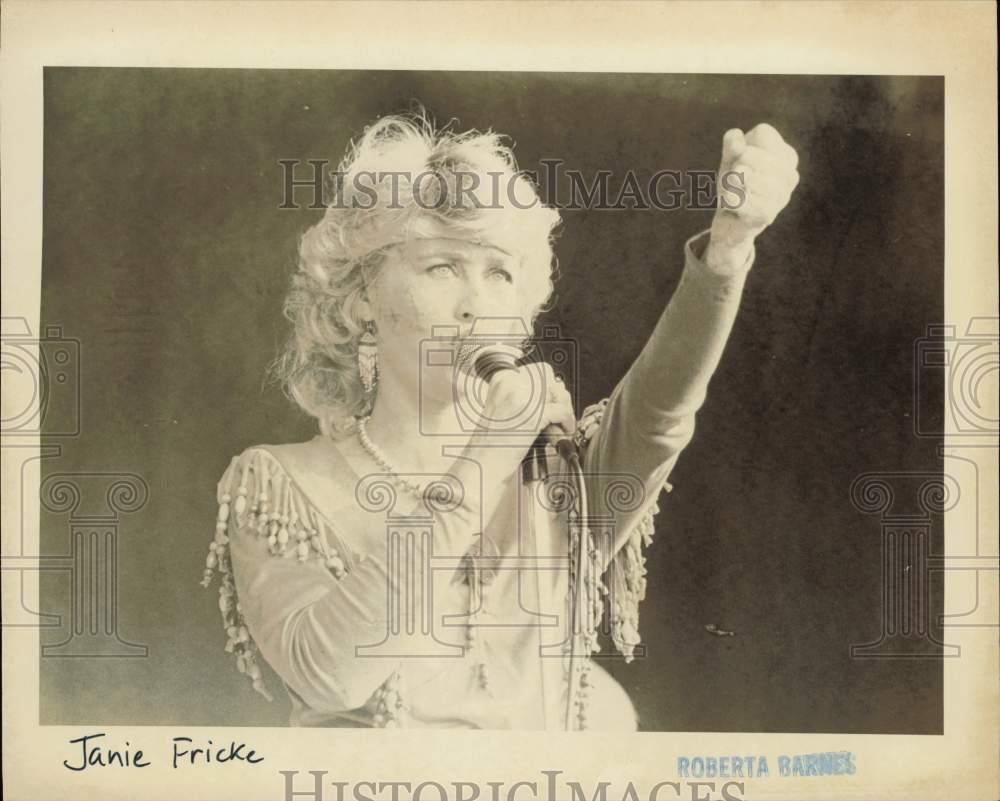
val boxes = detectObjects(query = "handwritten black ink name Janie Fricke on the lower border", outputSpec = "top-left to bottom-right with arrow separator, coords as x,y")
63,732 -> 264,771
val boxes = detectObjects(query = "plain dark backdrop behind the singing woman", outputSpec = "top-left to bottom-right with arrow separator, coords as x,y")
40,68 -> 944,733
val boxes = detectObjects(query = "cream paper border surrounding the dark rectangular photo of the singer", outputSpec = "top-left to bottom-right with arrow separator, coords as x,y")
0,1 -> 1000,799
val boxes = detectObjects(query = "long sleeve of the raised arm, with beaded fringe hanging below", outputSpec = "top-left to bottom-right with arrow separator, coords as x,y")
583,232 -> 754,656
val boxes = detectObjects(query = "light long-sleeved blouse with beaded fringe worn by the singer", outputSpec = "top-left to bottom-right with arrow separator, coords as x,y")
202,232 -> 753,731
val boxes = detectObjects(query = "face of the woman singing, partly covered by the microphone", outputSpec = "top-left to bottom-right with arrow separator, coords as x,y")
363,234 -> 531,402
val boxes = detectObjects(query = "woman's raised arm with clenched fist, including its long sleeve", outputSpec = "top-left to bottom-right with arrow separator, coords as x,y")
584,124 -> 798,566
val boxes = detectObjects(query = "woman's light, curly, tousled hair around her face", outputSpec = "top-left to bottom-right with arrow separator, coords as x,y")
271,108 -> 560,435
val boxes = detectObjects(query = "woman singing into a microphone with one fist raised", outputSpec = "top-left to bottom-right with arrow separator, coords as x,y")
203,109 -> 798,731
